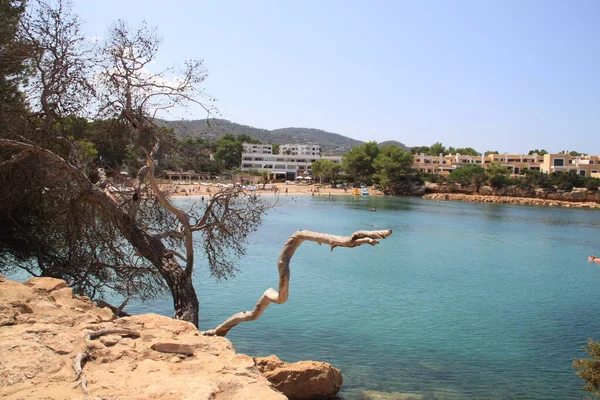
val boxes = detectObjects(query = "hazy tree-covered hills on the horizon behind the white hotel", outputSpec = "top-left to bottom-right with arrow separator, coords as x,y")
158,118 -> 407,155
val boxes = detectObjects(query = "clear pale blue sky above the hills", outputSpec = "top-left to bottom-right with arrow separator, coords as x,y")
73,0 -> 600,154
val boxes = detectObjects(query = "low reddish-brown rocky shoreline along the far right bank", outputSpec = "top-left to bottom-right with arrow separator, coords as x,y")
423,193 -> 600,209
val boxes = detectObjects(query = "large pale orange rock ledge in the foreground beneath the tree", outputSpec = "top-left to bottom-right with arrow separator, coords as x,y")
0,275 -> 285,400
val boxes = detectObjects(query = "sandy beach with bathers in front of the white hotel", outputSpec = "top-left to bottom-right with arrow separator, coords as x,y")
161,183 -> 383,197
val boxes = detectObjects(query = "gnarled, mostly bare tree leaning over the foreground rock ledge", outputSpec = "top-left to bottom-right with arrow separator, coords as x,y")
0,1 -> 266,326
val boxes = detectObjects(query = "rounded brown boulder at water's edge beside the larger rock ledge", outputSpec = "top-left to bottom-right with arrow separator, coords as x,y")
254,356 -> 343,399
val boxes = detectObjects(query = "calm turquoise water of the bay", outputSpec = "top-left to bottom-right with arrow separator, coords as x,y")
128,196 -> 600,399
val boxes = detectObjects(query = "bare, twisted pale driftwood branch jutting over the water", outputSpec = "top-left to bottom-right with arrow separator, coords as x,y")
202,229 -> 392,336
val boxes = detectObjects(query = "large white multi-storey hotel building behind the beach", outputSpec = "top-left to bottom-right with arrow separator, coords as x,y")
241,143 -> 342,180
